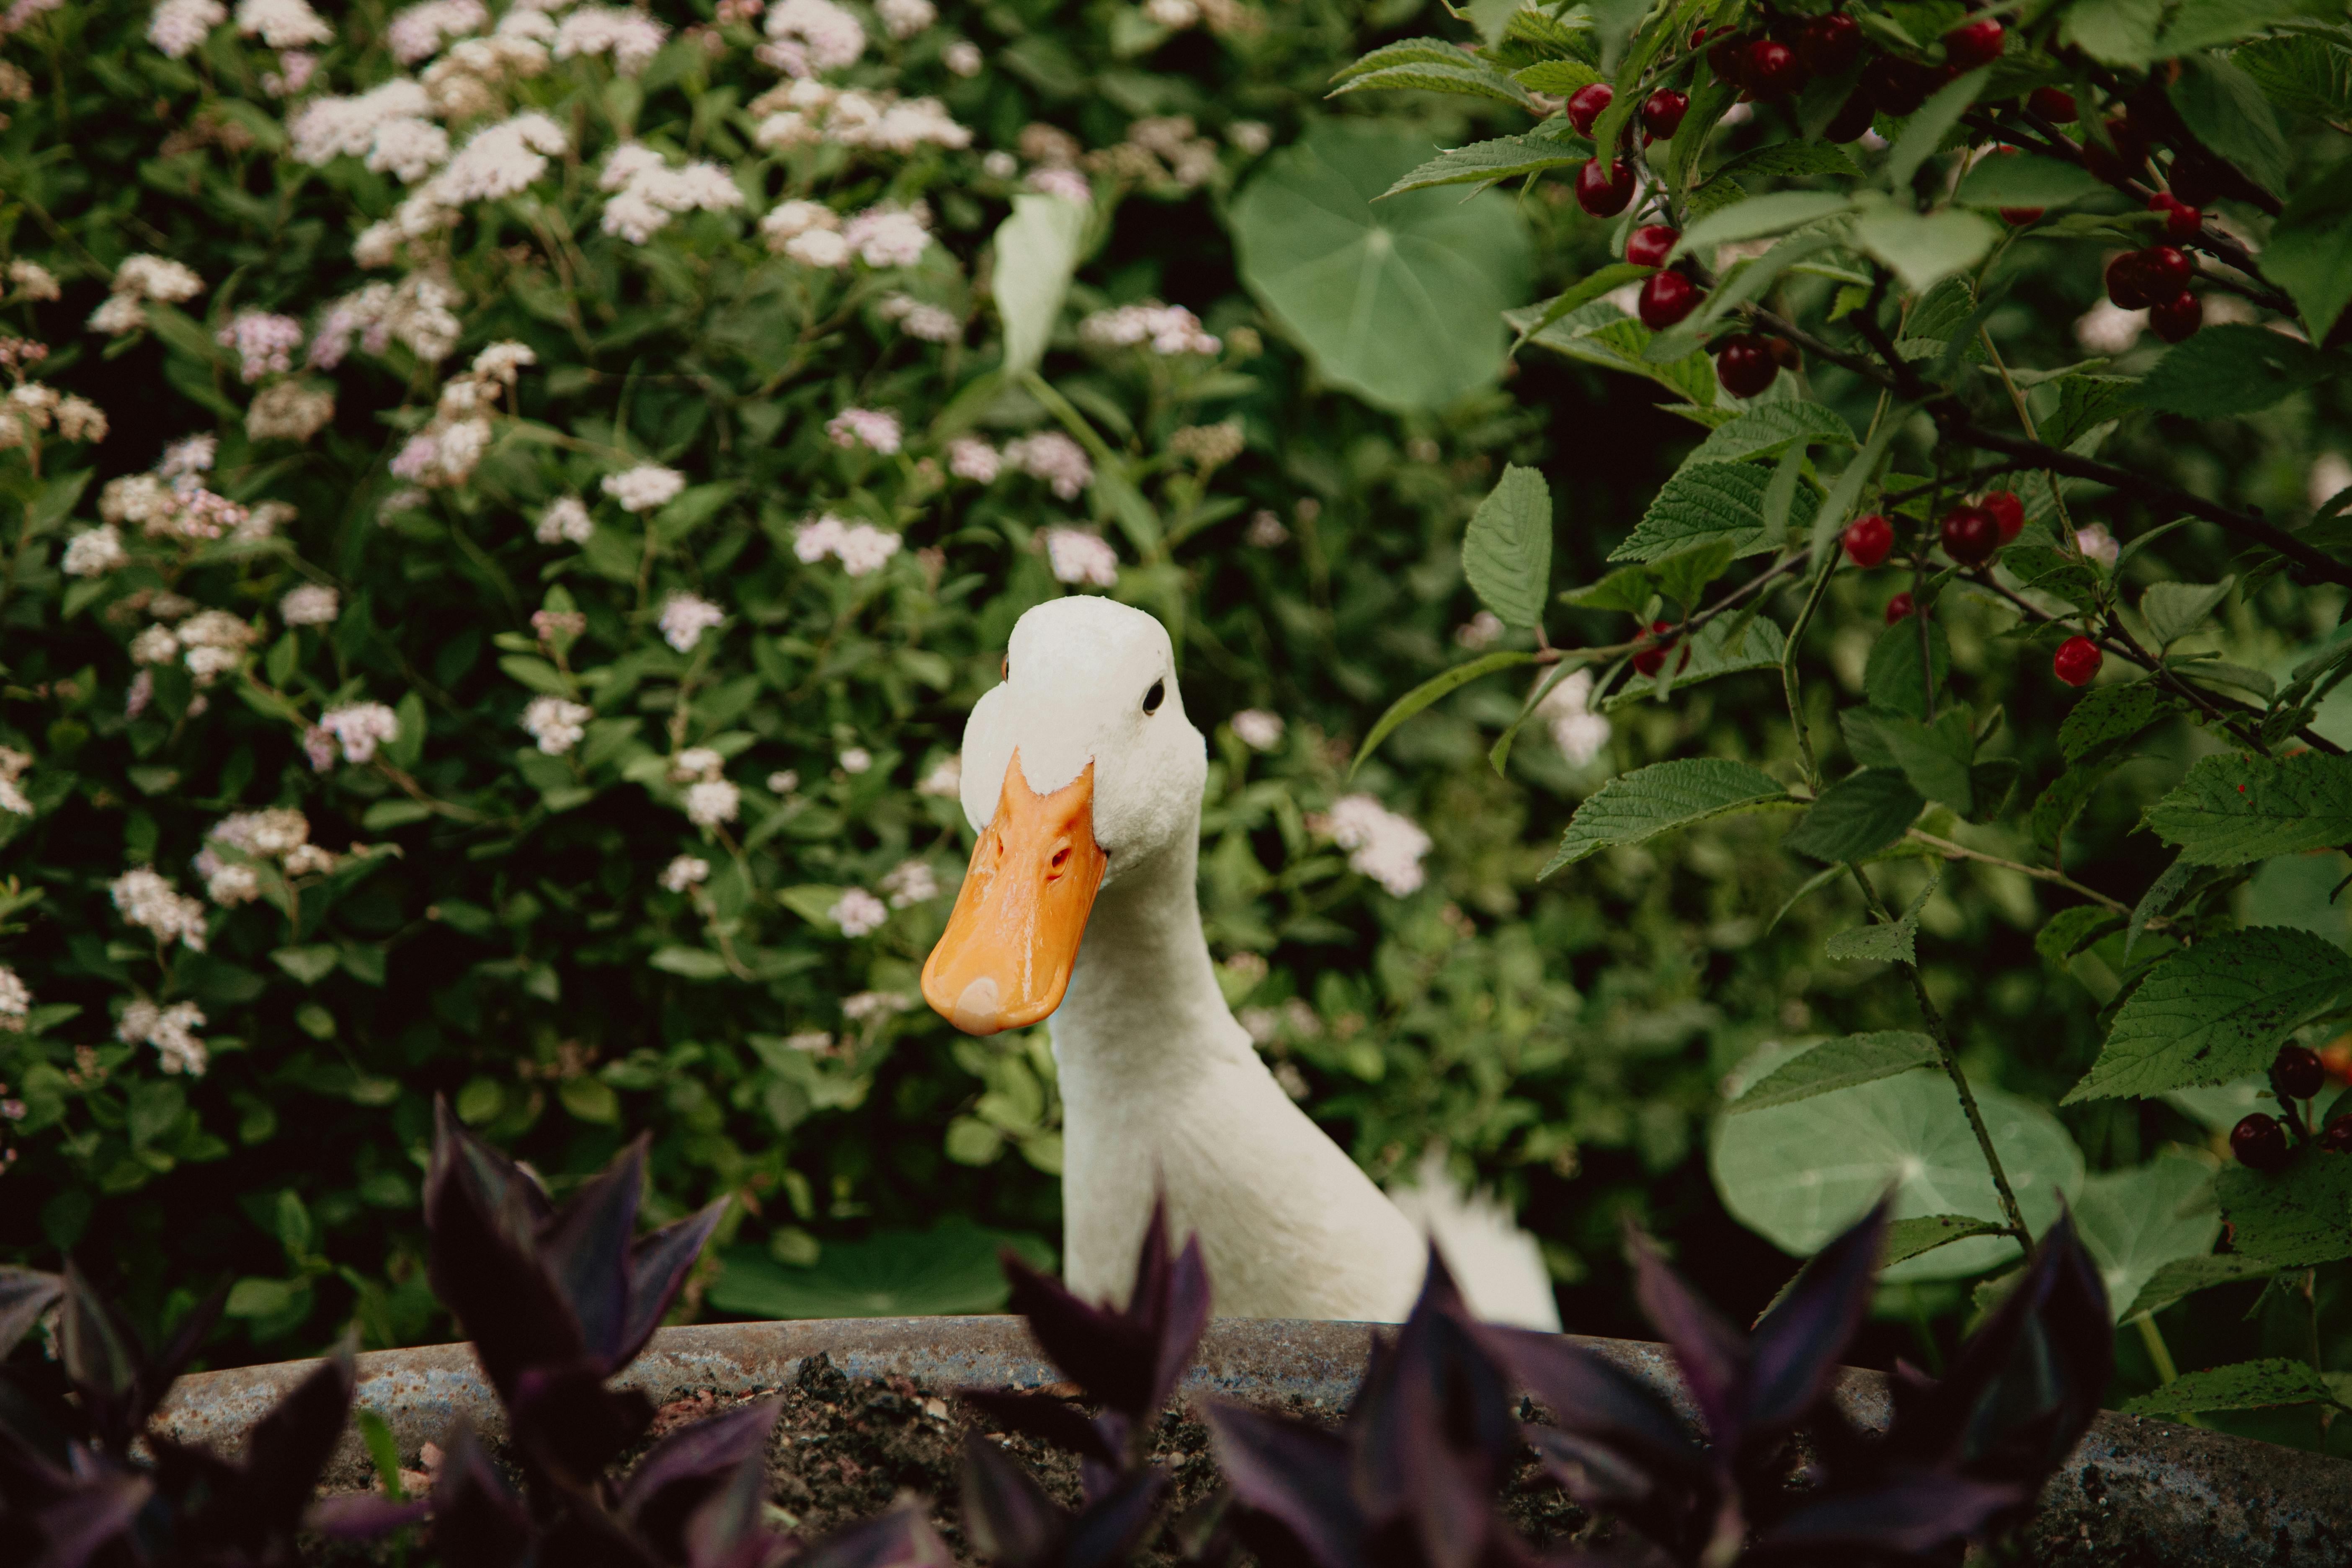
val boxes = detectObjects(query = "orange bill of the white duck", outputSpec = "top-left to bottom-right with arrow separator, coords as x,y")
922,752 -> 1110,1034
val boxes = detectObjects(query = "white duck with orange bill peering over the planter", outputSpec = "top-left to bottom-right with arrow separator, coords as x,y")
922,597 -> 1559,1328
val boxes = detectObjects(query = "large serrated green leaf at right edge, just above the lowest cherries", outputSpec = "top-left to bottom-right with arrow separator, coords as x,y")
2065,926 -> 2352,1105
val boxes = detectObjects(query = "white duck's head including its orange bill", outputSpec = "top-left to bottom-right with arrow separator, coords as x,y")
922,595 -> 1209,1034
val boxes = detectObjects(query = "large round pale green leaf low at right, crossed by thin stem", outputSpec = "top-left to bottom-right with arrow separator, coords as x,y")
1707,1070 -> 2081,1281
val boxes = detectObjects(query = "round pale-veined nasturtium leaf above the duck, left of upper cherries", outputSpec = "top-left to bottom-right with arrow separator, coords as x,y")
1233,120 -> 1531,411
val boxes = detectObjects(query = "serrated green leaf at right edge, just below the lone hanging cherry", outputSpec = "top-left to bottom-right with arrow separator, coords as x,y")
2147,752 -> 2352,865
